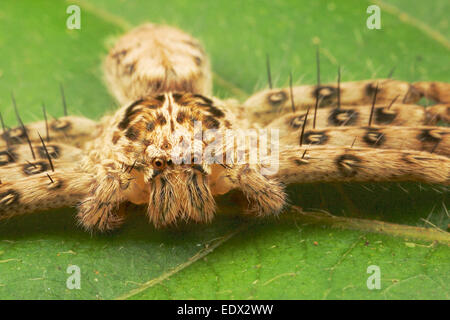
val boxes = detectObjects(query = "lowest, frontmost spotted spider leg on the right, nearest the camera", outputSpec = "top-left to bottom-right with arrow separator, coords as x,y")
270,146 -> 450,185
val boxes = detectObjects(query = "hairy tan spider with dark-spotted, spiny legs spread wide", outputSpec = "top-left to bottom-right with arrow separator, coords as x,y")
0,24 -> 450,231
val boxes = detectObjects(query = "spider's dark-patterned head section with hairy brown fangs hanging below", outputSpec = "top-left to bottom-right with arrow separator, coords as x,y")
109,93 -> 230,226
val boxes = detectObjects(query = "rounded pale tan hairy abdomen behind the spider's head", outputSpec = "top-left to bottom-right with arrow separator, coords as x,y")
104,24 -> 212,104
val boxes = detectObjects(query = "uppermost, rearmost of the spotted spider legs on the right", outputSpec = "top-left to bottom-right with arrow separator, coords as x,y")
242,79 -> 450,125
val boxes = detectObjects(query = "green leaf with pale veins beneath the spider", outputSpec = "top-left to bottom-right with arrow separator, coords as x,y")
0,0 -> 450,299
